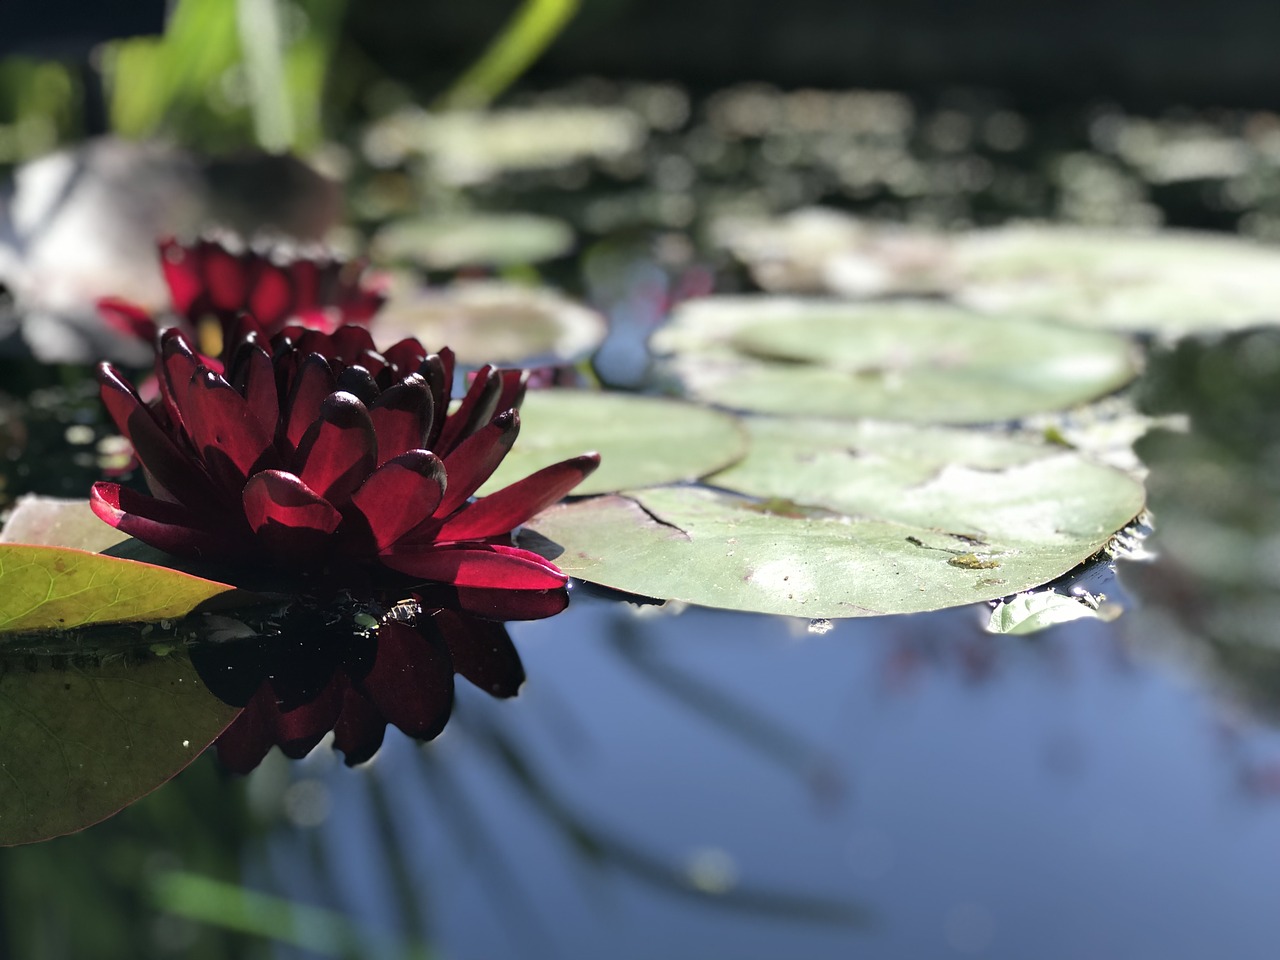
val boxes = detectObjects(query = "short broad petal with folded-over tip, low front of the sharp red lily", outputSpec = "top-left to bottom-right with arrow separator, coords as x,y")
243,470 -> 342,564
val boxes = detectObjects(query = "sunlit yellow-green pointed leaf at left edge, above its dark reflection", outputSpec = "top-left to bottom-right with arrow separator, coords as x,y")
0,544 -> 232,634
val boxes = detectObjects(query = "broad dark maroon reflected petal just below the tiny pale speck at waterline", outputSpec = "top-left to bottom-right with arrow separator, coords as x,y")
357,620 -> 453,740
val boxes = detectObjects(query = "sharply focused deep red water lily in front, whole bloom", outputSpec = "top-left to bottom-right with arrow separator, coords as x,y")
91,317 -> 599,617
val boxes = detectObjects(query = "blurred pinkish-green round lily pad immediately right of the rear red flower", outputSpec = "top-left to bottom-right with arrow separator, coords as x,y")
378,283 -> 607,365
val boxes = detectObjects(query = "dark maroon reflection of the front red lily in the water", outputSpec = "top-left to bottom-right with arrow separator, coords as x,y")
191,602 -> 538,773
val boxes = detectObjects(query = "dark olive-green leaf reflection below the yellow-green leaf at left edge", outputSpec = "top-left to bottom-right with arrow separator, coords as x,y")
0,652 -> 238,845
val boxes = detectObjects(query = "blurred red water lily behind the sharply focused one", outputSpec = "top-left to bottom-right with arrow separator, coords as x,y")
99,237 -> 384,356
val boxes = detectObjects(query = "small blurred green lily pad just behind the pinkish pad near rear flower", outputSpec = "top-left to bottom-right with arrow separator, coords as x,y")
370,214 -> 573,270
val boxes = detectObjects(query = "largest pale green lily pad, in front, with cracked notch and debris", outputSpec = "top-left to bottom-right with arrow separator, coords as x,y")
530,420 -> 1143,617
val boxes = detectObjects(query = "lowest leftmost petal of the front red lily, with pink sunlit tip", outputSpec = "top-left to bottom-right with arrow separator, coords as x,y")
88,481 -> 243,557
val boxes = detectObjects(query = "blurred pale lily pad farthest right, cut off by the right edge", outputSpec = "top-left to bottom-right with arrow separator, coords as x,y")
955,227 -> 1280,337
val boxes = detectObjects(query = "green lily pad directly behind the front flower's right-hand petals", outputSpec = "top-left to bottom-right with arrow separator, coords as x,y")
480,390 -> 746,495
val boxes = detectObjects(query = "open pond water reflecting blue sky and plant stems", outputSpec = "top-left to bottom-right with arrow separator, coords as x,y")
0,84 -> 1280,960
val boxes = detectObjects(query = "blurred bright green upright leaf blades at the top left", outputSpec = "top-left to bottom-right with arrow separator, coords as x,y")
0,0 -> 580,164
